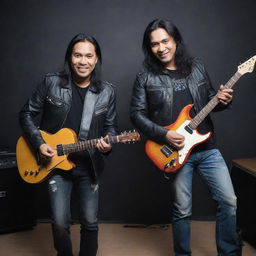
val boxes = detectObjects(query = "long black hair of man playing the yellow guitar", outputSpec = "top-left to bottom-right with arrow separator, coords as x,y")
64,33 -> 102,84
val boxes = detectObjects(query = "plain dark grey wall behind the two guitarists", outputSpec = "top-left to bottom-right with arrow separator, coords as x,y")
0,0 -> 256,223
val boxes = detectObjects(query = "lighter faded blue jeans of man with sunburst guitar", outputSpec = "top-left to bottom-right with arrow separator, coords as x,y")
172,149 -> 240,256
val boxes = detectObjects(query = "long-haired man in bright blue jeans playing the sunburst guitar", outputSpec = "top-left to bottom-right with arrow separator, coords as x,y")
130,19 -> 240,256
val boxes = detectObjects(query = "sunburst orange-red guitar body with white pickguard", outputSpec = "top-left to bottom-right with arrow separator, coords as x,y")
145,104 -> 212,173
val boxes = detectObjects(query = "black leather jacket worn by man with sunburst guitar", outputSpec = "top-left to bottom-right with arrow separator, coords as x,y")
130,60 -> 225,143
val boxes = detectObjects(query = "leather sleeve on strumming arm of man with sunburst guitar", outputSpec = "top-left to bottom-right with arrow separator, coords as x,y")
130,75 -> 168,142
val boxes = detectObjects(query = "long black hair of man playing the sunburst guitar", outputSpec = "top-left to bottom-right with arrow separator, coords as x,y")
142,19 -> 193,76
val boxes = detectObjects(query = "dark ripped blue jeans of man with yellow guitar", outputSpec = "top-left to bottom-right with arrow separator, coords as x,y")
48,170 -> 98,256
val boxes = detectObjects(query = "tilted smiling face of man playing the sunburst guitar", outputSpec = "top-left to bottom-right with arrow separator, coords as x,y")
150,28 -> 176,69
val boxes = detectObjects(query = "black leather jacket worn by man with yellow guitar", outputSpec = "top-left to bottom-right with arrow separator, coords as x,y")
20,73 -> 117,179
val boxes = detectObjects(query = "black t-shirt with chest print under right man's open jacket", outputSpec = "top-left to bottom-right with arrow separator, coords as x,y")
168,70 -> 215,152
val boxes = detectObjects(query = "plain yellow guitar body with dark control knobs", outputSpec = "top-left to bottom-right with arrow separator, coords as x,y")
16,128 -> 77,183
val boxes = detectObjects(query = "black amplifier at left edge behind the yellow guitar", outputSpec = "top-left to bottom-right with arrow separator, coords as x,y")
0,152 -> 35,233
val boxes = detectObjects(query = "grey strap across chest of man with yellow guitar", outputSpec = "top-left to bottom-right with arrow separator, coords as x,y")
78,90 -> 99,140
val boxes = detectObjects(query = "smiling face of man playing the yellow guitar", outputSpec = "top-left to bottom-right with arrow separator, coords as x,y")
71,41 -> 98,79
